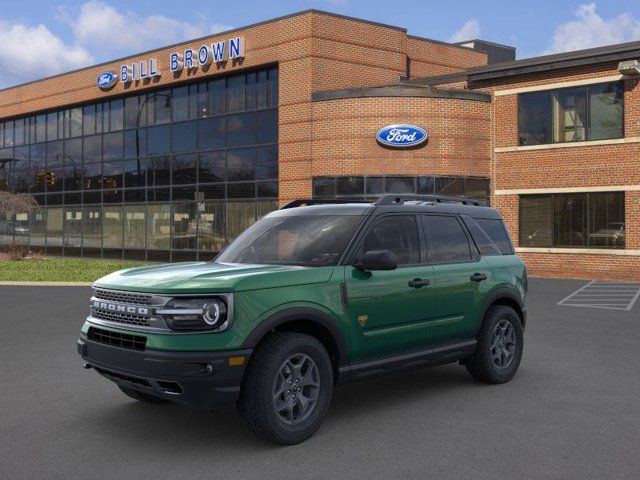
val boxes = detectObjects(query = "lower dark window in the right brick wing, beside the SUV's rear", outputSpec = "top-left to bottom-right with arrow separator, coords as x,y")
520,192 -> 625,248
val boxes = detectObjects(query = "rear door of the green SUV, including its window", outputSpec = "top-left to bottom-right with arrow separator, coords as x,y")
422,215 -> 494,343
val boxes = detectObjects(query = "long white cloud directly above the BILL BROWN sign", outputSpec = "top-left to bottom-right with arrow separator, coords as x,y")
60,0 -> 231,57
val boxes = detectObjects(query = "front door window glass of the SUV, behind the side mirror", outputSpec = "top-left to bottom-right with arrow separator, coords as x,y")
362,215 -> 420,265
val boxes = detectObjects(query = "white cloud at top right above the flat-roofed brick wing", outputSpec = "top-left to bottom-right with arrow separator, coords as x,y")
543,3 -> 640,54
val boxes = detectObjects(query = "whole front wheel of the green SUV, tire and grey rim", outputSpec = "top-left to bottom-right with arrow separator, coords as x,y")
238,332 -> 333,445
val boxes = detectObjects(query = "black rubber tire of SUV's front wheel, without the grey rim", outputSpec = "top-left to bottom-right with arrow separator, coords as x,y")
238,332 -> 333,445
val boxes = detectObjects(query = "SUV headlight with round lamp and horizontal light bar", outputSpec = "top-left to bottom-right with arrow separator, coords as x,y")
156,298 -> 229,330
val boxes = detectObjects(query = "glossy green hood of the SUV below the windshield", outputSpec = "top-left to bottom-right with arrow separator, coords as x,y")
94,262 -> 333,293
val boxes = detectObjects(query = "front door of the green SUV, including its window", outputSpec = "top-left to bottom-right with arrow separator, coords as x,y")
345,214 -> 435,361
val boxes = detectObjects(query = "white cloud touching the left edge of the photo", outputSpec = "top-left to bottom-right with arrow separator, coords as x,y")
0,20 -> 94,88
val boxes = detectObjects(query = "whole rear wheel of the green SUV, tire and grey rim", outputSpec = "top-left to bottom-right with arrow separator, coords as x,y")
467,305 -> 524,383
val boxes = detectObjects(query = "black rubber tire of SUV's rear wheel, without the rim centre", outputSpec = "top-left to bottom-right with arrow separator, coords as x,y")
467,305 -> 524,384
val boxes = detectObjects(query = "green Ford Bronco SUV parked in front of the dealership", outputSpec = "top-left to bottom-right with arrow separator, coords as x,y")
78,195 -> 527,444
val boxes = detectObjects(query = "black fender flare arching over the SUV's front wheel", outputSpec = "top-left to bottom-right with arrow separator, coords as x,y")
242,307 -> 348,365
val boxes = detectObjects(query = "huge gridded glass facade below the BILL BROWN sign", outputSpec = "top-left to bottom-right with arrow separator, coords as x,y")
0,67 -> 278,260
